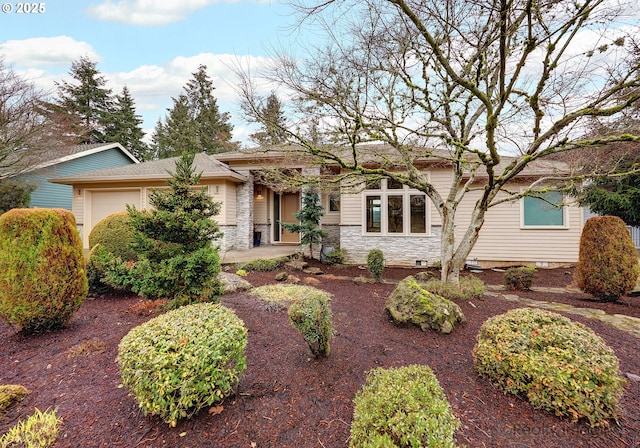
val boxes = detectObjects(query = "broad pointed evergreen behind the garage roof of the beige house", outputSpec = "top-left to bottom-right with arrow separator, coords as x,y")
153,65 -> 237,158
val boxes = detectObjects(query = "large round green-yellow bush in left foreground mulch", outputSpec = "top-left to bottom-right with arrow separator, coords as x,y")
117,303 -> 247,427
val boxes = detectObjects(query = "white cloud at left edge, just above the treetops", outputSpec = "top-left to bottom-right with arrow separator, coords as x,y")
0,36 -> 101,68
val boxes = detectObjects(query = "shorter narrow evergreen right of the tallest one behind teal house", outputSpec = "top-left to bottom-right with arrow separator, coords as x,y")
105,86 -> 151,161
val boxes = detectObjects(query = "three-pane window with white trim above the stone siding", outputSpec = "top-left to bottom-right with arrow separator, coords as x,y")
363,179 -> 428,235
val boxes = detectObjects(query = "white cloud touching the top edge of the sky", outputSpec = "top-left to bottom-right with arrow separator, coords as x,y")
88,0 -> 240,26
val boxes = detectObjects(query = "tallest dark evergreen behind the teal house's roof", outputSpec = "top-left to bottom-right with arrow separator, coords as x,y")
55,57 -> 113,143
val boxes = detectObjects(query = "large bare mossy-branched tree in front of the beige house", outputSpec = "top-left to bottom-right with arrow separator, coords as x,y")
239,0 -> 640,282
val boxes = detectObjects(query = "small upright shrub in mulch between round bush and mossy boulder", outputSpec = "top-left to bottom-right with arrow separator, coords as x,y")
289,286 -> 333,357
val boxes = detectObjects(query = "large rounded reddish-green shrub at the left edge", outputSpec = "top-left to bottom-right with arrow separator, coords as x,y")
0,208 -> 88,334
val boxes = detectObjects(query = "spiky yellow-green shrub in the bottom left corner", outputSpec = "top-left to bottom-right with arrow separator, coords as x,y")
0,408 -> 61,448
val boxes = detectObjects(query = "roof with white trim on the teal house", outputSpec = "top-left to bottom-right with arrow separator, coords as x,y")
7,143 -> 139,174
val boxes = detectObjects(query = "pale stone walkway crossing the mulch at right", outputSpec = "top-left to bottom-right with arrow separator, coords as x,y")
486,286 -> 640,338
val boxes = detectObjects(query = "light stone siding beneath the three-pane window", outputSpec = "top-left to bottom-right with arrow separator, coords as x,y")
340,226 -> 441,266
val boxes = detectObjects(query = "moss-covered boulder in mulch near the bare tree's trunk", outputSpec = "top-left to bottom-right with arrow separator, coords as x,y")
385,276 -> 465,334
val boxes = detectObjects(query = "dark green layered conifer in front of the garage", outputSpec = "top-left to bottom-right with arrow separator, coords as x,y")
100,153 -> 221,308
